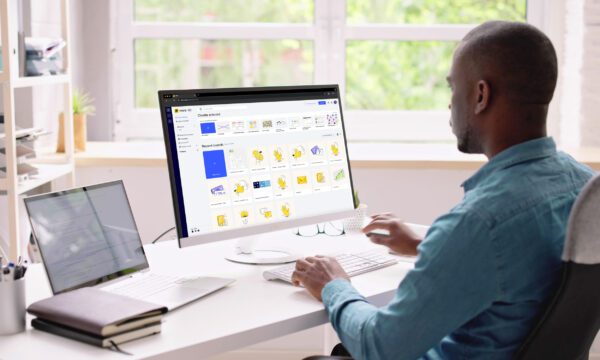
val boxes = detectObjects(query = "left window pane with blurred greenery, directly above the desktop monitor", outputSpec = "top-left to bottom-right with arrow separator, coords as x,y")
135,39 -> 314,108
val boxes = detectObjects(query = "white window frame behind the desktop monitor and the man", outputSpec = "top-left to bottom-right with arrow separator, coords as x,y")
111,0 -> 558,142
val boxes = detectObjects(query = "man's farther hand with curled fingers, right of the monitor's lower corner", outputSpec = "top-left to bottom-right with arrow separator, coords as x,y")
363,213 -> 421,255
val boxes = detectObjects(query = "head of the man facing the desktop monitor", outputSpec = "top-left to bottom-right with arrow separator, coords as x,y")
448,21 -> 558,155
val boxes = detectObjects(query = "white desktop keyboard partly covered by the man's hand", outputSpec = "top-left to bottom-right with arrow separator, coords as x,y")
263,249 -> 398,283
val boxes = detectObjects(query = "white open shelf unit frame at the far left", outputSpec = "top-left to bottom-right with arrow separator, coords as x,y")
0,0 -> 75,260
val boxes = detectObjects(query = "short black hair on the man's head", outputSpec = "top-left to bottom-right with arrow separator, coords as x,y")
461,21 -> 558,105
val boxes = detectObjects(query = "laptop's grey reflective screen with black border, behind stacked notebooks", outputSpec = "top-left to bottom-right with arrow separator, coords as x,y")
24,180 -> 148,294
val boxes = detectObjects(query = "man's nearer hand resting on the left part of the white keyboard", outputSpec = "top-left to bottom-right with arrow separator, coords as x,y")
292,255 -> 350,301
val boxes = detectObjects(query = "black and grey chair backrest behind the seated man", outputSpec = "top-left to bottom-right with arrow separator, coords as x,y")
516,176 -> 600,360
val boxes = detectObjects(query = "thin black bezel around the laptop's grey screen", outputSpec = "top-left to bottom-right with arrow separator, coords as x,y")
23,180 -> 149,295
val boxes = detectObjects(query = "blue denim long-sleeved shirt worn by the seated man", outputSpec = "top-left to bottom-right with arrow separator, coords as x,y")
322,138 -> 593,360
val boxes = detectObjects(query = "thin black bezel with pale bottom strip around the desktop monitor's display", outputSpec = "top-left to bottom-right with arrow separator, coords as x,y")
158,84 -> 355,248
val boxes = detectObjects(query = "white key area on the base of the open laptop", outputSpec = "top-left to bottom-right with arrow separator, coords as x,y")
103,274 -> 185,300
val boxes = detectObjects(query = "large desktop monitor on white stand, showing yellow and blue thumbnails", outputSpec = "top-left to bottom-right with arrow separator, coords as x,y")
158,85 -> 354,263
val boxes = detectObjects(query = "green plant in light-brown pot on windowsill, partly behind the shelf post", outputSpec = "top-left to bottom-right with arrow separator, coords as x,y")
56,89 -> 96,152
